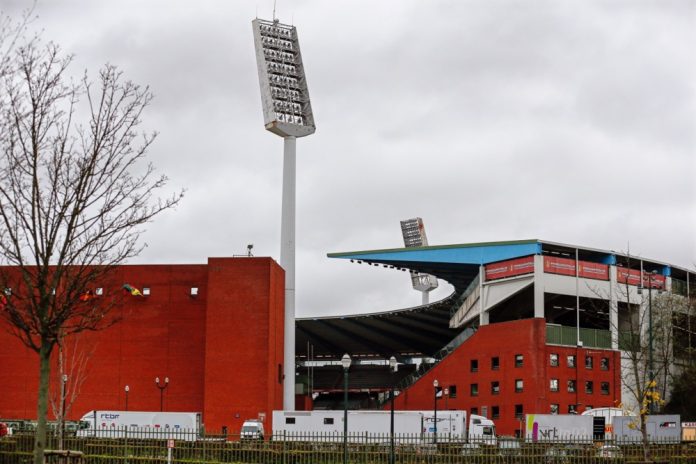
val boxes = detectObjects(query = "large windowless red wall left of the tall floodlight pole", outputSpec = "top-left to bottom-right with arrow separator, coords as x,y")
0,258 -> 284,433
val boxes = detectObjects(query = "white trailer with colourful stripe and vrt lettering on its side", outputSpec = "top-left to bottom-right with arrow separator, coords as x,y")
525,414 -> 594,443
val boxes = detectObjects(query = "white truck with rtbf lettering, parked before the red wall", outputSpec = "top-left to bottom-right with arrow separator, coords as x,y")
76,411 -> 202,441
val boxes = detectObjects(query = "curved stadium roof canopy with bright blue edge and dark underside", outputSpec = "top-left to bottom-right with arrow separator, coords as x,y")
295,240 -> 541,359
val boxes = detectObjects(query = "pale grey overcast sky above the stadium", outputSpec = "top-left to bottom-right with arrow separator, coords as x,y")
0,0 -> 696,316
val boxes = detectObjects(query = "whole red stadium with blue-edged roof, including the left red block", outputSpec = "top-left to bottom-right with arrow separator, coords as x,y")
0,240 -> 696,435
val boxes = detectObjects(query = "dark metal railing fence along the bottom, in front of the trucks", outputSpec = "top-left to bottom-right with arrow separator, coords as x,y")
0,430 -> 696,464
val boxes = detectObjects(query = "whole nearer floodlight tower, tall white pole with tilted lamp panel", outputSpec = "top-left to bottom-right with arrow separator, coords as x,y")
252,19 -> 316,411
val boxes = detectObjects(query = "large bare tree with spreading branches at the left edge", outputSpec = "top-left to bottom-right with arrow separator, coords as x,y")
0,41 -> 182,464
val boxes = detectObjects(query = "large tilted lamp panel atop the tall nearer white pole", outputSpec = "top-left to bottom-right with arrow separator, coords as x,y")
252,19 -> 315,137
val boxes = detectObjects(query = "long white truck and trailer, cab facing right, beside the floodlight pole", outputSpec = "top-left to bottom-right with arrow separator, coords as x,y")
273,410 -> 495,443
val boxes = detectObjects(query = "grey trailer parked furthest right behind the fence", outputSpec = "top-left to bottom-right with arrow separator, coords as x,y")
612,414 -> 682,443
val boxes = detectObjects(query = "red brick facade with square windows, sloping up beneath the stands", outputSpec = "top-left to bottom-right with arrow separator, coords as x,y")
395,318 -> 621,435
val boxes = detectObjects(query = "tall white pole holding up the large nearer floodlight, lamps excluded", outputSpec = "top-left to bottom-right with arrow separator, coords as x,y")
280,136 -> 296,411
